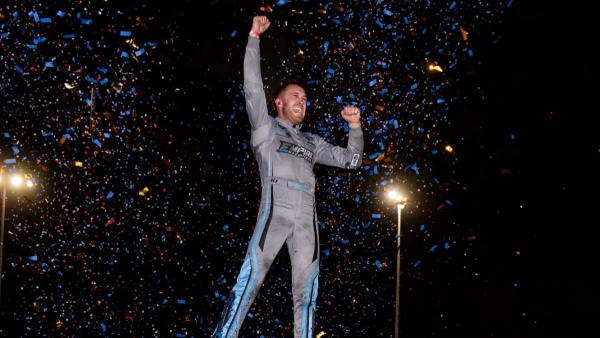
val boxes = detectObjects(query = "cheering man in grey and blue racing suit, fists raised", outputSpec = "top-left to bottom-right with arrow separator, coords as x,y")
214,16 -> 363,338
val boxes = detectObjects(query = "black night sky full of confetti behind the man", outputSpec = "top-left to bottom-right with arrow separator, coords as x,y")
0,0 -> 600,337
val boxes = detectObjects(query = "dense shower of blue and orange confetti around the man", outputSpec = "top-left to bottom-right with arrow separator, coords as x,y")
0,0 -> 522,337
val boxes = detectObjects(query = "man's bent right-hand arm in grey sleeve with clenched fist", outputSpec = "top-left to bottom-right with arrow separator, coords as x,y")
316,107 -> 364,169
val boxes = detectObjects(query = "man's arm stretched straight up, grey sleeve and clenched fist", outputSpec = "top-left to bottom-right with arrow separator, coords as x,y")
244,16 -> 271,131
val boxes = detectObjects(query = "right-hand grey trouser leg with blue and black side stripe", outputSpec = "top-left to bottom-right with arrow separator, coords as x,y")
287,209 -> 319,338
